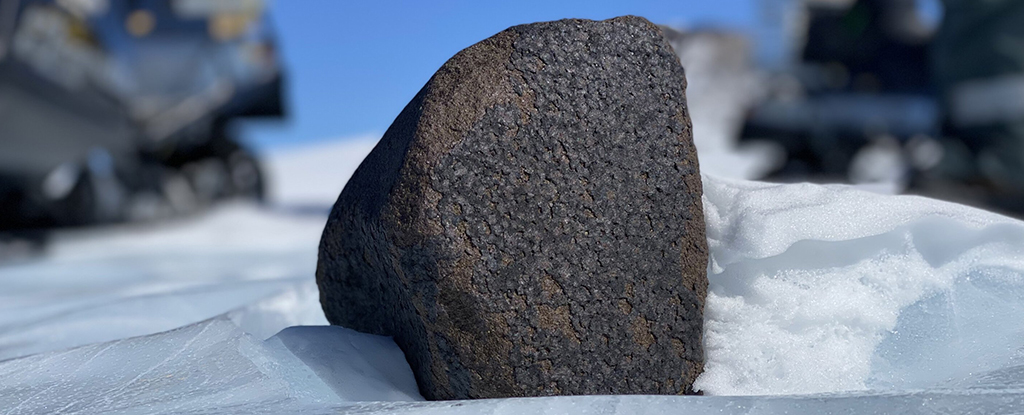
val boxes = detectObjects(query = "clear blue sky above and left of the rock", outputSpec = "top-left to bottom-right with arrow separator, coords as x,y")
235,0 -> 759,149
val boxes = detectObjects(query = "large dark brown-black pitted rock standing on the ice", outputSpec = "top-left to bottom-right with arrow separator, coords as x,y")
316,16 -> 708,400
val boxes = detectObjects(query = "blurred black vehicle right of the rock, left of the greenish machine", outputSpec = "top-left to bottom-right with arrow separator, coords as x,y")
741,0 -> 942,186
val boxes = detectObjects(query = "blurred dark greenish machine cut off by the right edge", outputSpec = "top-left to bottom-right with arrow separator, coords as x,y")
933,0 -> 1024,214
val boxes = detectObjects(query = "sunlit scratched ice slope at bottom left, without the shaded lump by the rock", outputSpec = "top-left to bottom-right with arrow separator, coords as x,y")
0,319 -> 330,414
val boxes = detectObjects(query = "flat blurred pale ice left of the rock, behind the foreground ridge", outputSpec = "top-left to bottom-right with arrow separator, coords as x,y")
0,205 -> 326,360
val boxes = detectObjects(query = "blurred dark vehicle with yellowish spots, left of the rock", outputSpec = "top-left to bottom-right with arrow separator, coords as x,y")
0,0 -> 284,231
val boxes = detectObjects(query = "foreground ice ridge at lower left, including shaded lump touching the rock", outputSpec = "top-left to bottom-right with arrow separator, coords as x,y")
0,318 -> 422,414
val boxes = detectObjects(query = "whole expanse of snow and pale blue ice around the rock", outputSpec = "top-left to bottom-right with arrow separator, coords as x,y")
0,139 -> 1024,414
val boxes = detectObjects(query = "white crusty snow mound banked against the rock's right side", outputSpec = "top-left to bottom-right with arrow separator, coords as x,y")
695,177 -> 1024,395
